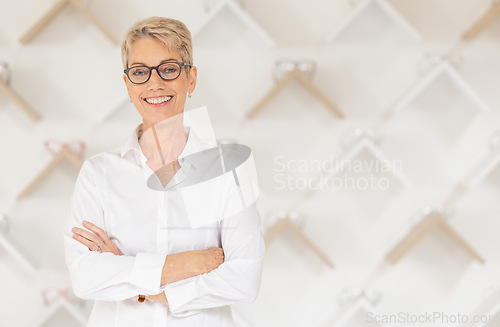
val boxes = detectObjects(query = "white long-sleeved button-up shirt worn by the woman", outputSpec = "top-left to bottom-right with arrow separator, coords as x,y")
64,121 -> 265,327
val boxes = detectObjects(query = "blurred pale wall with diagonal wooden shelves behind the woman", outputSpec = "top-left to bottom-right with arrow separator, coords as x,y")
0,0 -> 500,327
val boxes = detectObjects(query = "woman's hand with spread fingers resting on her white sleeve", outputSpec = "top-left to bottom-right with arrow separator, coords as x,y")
71,221 -> 123,255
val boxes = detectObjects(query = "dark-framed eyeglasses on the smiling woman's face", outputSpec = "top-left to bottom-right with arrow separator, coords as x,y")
123,61 -> 192,84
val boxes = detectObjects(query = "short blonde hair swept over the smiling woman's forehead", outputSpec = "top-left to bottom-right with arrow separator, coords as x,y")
122,17 -> 193,69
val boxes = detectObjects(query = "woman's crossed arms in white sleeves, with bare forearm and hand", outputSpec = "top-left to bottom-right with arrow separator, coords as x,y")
64,158 -> 265,317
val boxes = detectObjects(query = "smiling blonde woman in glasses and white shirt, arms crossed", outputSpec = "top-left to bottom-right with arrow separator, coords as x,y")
64,17 -> 265,327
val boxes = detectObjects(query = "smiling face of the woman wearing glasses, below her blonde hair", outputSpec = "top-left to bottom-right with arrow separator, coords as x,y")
123,38 -> 197,131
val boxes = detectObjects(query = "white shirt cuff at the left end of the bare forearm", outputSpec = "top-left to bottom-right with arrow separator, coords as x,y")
130,252 -> 167,294
